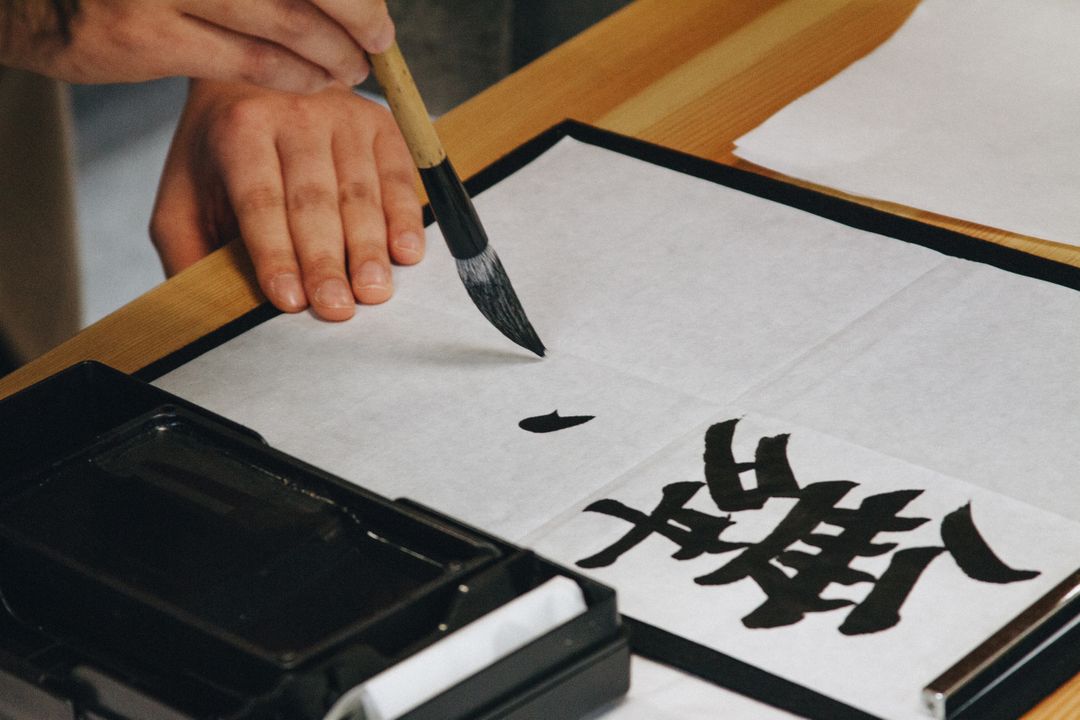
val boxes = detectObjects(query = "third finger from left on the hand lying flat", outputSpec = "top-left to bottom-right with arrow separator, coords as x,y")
334,116 -> 393,304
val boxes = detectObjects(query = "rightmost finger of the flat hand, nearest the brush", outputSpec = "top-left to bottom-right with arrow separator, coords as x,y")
375,115 -> 424,264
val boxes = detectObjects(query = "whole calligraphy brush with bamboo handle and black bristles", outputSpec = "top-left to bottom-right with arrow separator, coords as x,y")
369,42 -> 544,357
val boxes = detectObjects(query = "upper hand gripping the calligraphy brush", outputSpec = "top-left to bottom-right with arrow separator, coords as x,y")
0,0 -> 394,93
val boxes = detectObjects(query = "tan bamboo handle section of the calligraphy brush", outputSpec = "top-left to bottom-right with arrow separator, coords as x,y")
368,42 -> 446,169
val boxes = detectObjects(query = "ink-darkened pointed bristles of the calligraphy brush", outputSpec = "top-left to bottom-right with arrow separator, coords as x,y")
455,245 -> 544,357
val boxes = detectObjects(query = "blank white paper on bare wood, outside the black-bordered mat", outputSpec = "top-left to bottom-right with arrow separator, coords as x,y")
735,0 -> 1080,245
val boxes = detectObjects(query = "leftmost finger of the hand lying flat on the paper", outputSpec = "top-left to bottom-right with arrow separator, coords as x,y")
212,104 -> 308,312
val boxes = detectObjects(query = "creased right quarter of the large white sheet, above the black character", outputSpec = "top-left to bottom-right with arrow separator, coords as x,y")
740,263 -> 1080,520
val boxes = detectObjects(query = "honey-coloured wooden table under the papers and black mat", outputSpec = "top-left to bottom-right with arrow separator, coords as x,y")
0,0 -> 1080,720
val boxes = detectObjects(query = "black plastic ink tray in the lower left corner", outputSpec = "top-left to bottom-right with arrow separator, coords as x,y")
0,363 -> 629,720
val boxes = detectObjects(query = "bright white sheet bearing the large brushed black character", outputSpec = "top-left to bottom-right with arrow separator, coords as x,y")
526,416 -> 1080,720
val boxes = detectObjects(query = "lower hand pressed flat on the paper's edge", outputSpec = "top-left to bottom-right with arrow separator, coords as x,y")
150,81 -> 423,321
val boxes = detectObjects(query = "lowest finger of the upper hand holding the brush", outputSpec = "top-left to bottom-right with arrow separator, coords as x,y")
165,14 -> 334,94
